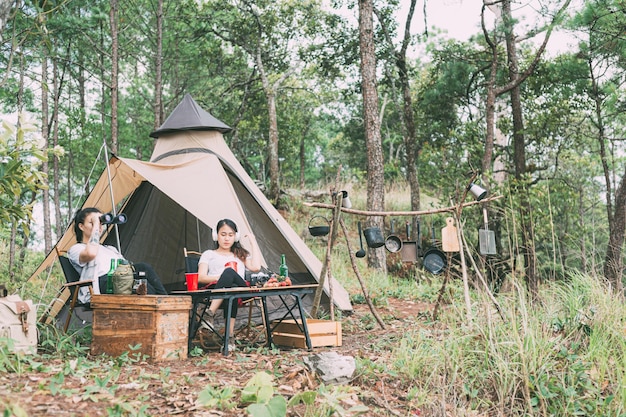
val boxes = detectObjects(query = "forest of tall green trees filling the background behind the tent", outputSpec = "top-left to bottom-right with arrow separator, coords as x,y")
0,0 -> 626,292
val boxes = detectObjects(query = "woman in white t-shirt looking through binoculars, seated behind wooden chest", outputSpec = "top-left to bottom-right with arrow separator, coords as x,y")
67,207 -> 167,303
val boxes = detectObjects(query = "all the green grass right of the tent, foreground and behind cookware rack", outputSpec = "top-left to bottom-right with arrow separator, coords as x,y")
290,188 -> 626,417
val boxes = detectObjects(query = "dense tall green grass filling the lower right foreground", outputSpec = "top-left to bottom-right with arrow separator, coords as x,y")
386,274 -> 626,416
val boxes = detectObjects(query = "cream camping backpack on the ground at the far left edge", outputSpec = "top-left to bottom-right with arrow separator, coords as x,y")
0,285 -> 37,353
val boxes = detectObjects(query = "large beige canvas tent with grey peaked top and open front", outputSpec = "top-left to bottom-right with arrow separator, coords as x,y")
31,95 -> 352,324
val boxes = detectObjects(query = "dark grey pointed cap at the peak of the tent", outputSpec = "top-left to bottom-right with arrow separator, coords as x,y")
150,93 -> 232,138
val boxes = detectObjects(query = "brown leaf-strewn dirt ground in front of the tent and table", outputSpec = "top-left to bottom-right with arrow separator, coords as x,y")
0,299 -> 433,416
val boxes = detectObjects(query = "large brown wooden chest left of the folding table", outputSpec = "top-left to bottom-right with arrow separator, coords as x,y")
91,294 -> 191,361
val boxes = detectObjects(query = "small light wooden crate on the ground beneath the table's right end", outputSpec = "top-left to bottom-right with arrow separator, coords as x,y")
272,319 -> 341,349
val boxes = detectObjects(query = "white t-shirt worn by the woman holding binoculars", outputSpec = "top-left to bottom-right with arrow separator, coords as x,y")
67,243 -> 124,302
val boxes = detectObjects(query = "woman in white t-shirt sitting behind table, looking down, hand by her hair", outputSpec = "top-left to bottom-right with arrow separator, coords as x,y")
198,219 -> 261,334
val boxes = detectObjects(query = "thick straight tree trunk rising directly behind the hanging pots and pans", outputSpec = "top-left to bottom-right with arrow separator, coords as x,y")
359,0 -> 387,271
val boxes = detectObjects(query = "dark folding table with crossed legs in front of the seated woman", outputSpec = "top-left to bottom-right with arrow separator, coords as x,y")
172,284 -> 318,356
